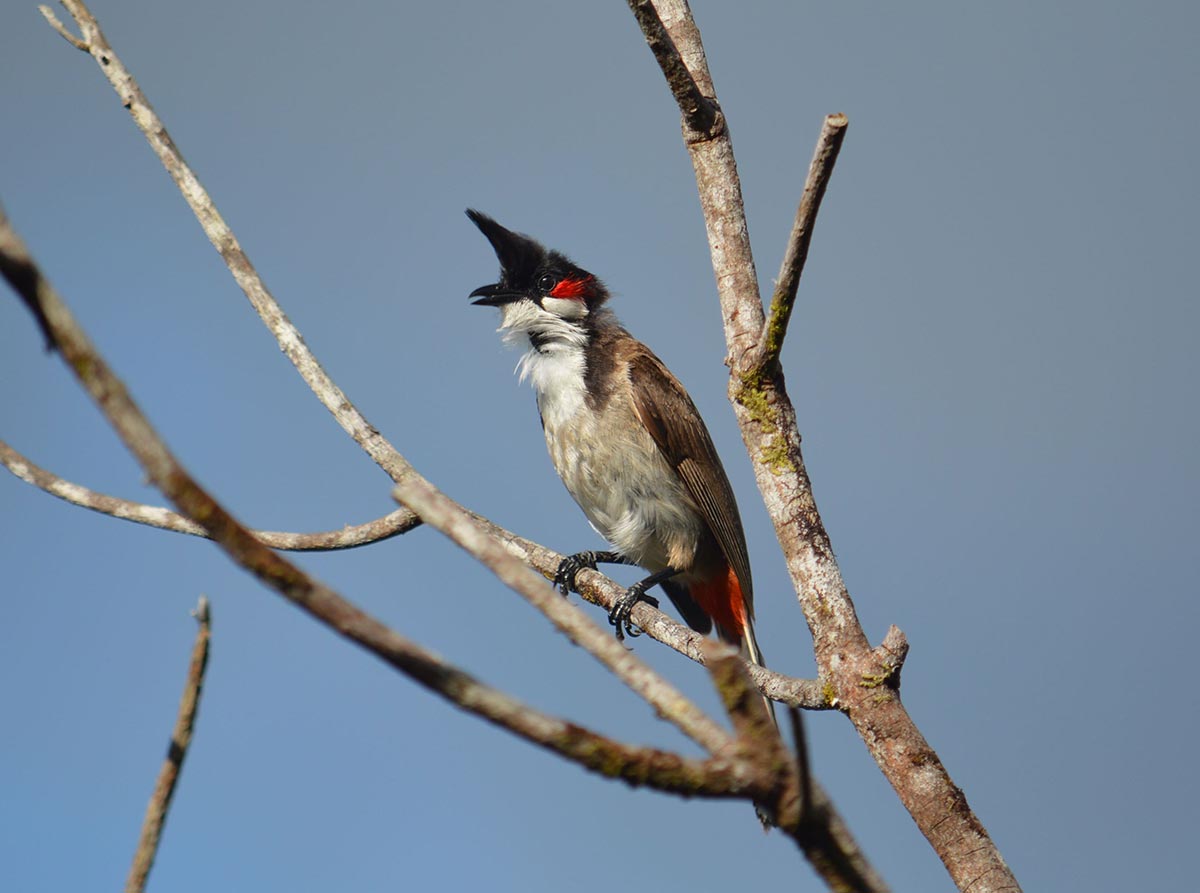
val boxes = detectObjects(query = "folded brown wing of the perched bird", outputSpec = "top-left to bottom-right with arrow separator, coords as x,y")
629,347 -> 754,618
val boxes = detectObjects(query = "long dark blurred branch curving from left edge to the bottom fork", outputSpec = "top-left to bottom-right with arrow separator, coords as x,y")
0,209 -> 774,798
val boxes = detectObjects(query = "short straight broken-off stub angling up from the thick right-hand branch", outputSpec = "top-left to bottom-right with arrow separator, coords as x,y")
749,114 -> 850,368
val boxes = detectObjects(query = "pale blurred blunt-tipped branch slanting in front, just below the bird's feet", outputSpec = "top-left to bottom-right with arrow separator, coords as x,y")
394,481 -> 729,754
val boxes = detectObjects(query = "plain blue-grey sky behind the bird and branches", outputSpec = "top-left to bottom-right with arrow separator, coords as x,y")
0,0 -> 1200,893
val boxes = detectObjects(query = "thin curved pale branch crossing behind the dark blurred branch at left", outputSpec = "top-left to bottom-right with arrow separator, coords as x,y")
0,440 -> 421,552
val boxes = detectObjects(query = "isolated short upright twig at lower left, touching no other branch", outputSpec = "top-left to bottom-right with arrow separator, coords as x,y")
125,595 -> 211,893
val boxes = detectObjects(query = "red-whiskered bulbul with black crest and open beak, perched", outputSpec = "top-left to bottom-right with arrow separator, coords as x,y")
467,210 -> 769,681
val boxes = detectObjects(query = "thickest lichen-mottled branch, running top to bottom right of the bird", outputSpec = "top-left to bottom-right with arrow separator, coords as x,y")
630,0 -> 1020,893
